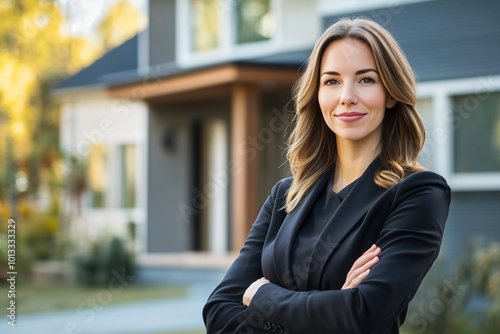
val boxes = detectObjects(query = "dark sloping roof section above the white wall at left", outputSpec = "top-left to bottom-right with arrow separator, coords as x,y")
55,35 -> 138,89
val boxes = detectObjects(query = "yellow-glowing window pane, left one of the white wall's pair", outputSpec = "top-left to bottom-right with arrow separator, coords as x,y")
87,145 -> 108,208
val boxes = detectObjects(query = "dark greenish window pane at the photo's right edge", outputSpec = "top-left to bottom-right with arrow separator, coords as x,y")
453,92 -> 500,173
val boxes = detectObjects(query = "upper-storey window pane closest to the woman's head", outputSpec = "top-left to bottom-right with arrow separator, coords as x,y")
235,0 -> 274,43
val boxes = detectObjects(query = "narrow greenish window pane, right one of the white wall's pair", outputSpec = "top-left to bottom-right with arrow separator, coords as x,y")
120,145 -> 136,208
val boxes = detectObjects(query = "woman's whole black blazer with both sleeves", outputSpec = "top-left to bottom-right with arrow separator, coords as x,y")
203,158 -> 450,334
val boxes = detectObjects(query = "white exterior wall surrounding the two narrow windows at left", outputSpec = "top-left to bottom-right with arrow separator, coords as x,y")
60,90 -> 147,251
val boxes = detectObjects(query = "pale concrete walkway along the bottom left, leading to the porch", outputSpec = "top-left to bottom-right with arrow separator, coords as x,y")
0,270 -> 223,334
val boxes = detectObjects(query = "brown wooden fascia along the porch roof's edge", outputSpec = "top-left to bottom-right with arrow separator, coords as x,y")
108,64 -> 298,100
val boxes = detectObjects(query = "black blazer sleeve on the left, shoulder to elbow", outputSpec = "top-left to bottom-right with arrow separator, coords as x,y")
203,180 -> 284,334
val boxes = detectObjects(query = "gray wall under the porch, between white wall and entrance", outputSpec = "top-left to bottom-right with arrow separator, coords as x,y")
147,108 -> 192,253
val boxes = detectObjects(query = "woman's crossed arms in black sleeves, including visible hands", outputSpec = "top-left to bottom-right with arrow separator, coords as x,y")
203,172 -> 450,334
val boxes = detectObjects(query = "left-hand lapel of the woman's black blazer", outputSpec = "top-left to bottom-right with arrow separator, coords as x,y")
273,172 -> 329,290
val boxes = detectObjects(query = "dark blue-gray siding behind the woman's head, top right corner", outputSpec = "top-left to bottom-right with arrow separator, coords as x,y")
323,0 -> 500,81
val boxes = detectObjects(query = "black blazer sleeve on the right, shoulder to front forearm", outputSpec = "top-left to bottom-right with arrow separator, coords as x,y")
247,172 -> 450,334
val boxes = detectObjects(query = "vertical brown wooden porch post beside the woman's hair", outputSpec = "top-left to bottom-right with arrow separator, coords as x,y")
230,84 -> 260,251
